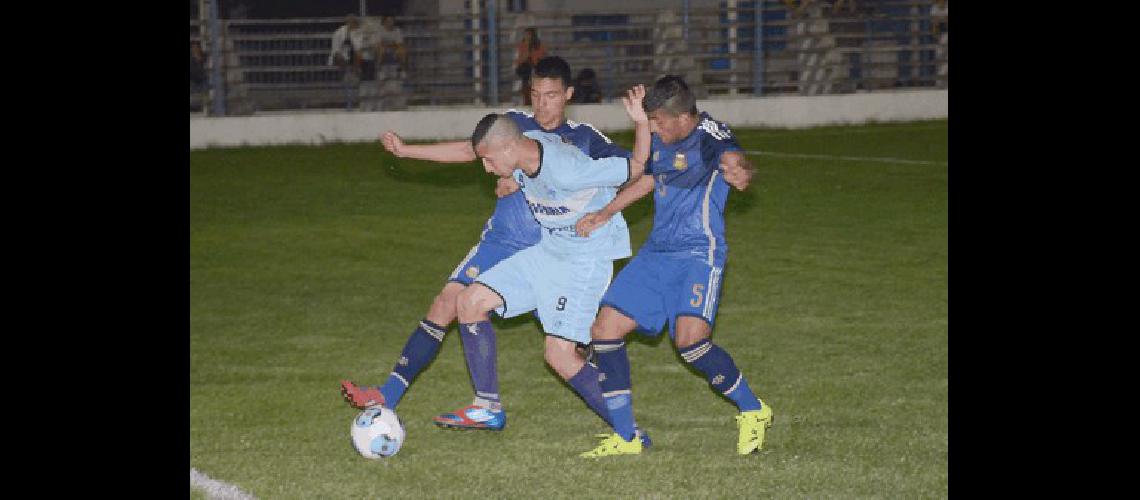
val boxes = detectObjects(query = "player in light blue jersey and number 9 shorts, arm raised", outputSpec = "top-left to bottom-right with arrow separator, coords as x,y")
444,87 -> 650,437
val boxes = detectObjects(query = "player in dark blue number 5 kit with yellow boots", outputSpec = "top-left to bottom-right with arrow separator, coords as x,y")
577,75 -> 772,458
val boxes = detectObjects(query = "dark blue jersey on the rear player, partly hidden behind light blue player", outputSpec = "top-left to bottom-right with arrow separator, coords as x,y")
481,109 -> 629,249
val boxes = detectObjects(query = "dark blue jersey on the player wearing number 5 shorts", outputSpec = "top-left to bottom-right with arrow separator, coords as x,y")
642,112 -> 741,267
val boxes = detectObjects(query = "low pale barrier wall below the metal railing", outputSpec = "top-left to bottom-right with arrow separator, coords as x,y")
190,90 -> 950,149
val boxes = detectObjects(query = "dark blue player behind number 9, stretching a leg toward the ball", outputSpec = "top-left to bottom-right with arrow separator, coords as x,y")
341,56 -> 649,444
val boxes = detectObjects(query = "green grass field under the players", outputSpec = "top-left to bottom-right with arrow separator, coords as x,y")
189,121 -> 948,499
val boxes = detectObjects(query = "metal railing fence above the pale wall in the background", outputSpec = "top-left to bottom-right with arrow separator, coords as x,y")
190,0 -> 948,114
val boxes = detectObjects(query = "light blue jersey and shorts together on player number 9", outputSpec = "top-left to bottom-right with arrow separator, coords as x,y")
475,131 -> 630,344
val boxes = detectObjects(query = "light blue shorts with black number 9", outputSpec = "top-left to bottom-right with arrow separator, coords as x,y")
475,244 -> 613,344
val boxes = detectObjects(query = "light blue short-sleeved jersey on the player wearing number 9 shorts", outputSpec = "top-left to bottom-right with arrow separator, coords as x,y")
514,131 -> 632,260
